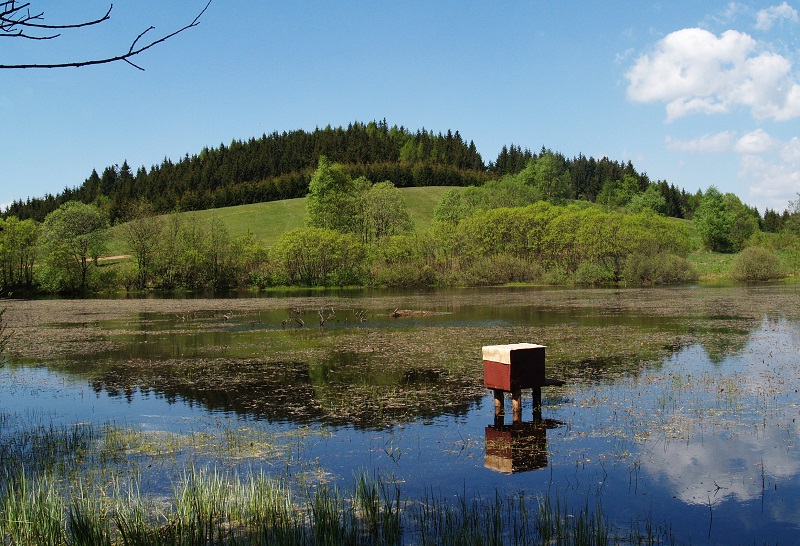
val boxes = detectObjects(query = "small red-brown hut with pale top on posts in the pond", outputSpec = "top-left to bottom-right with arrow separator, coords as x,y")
483,343 -> 564,415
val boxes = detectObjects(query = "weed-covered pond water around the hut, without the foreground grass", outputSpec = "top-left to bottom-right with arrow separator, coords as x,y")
0,284 -> 800,544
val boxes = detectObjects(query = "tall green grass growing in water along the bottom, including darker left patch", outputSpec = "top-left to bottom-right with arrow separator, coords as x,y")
0,418 -> 672,546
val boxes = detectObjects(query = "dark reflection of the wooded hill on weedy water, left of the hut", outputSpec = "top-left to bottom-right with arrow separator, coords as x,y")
83,352 -> 484,428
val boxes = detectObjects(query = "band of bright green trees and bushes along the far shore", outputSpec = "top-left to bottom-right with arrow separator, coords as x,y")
0,153 -> 800,293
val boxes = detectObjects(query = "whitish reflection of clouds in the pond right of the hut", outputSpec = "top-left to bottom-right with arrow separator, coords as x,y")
641,317 -> 800,508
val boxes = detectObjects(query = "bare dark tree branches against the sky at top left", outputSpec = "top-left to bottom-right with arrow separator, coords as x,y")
0,0 -> 212,70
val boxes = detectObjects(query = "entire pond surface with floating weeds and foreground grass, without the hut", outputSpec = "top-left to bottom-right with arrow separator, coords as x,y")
0,284 -> 800,544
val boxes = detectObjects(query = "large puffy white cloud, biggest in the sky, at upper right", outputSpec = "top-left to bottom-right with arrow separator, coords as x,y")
626,28 -> 800,121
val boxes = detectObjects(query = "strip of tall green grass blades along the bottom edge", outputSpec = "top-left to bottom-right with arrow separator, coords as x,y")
0,471 -> 669,546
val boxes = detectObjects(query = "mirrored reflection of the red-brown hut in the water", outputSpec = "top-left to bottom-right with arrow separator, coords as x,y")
484,416 -> 561,474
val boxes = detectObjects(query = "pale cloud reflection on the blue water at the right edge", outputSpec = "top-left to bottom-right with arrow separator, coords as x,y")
640,319 -> 800,504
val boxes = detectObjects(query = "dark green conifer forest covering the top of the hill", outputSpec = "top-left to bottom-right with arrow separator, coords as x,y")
4,121 -> 686,223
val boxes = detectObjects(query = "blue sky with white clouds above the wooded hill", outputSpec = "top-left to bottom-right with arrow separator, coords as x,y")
0,0 -> 800,213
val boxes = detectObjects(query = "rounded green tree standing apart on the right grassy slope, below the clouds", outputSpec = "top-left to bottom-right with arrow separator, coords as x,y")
694,186 -> 758,252
